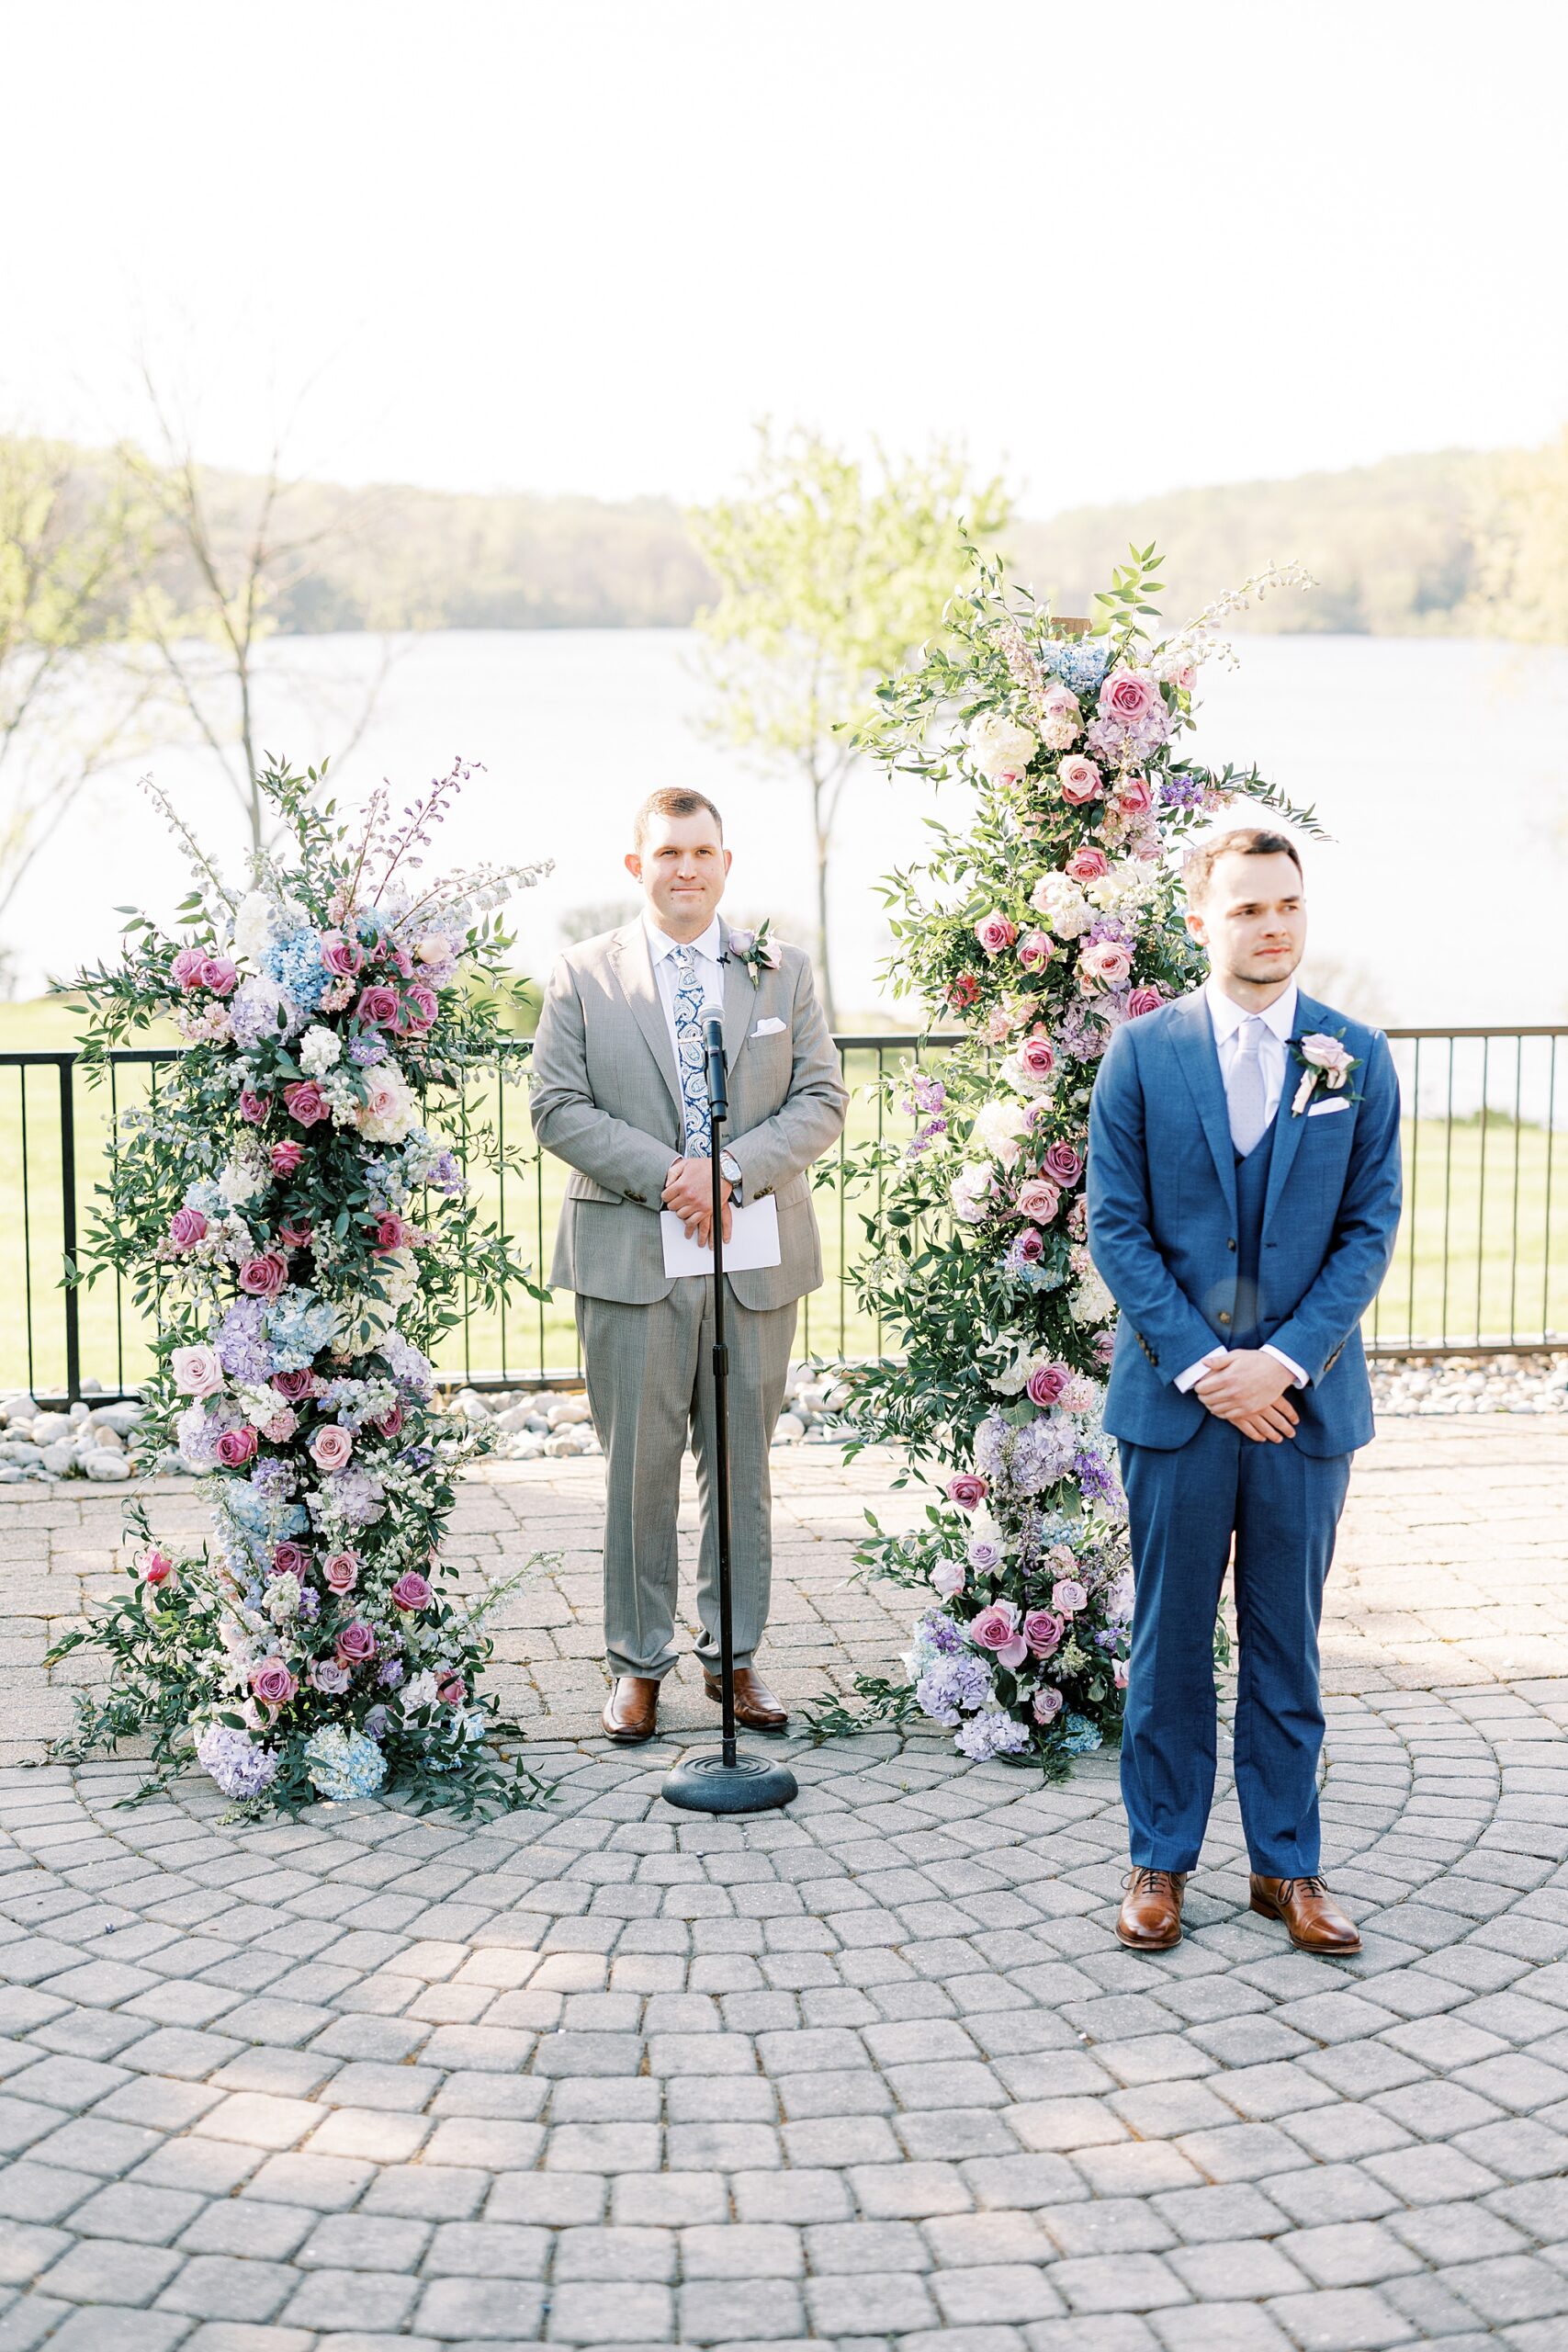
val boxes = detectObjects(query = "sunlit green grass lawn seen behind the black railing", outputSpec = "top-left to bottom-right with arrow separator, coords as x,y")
0,1002 -> 1568,1393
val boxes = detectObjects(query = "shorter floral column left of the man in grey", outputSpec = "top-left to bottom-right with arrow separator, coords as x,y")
54,764 -> 547,1811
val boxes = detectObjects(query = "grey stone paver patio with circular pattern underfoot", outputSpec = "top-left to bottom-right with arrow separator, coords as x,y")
0,1419 -> 1568,2352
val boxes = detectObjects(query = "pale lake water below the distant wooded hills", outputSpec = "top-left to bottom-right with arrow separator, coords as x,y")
12,630 -> 1568,1025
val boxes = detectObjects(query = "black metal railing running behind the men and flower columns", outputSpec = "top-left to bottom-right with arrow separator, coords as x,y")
0,1028 -> 1568,1399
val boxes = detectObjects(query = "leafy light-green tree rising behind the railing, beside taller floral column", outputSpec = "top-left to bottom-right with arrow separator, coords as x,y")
691,425 -> 1010,1025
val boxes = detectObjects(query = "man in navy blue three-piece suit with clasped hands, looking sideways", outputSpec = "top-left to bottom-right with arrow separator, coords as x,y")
1089,828 -> 1401,1952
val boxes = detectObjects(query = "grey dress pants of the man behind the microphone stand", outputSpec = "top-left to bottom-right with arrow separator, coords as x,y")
576,1275 -> 797,1681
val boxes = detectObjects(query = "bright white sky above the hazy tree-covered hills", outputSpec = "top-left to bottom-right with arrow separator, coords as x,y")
0,0 -> 1568,513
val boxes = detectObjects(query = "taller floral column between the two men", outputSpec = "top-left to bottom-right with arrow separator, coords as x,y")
841,548 -> 1316,1771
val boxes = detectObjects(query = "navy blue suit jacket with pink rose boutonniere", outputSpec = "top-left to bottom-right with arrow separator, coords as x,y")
1089,990 -> 1401,1456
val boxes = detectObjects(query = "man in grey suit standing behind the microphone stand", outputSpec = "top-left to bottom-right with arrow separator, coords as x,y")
531,790 -> 849,1746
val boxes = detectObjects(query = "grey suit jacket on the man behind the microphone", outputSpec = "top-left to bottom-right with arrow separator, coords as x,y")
531,922 -> 849,1307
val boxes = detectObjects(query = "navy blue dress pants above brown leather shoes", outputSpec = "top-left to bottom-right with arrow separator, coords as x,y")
1119,1414 -> 1352,1879
